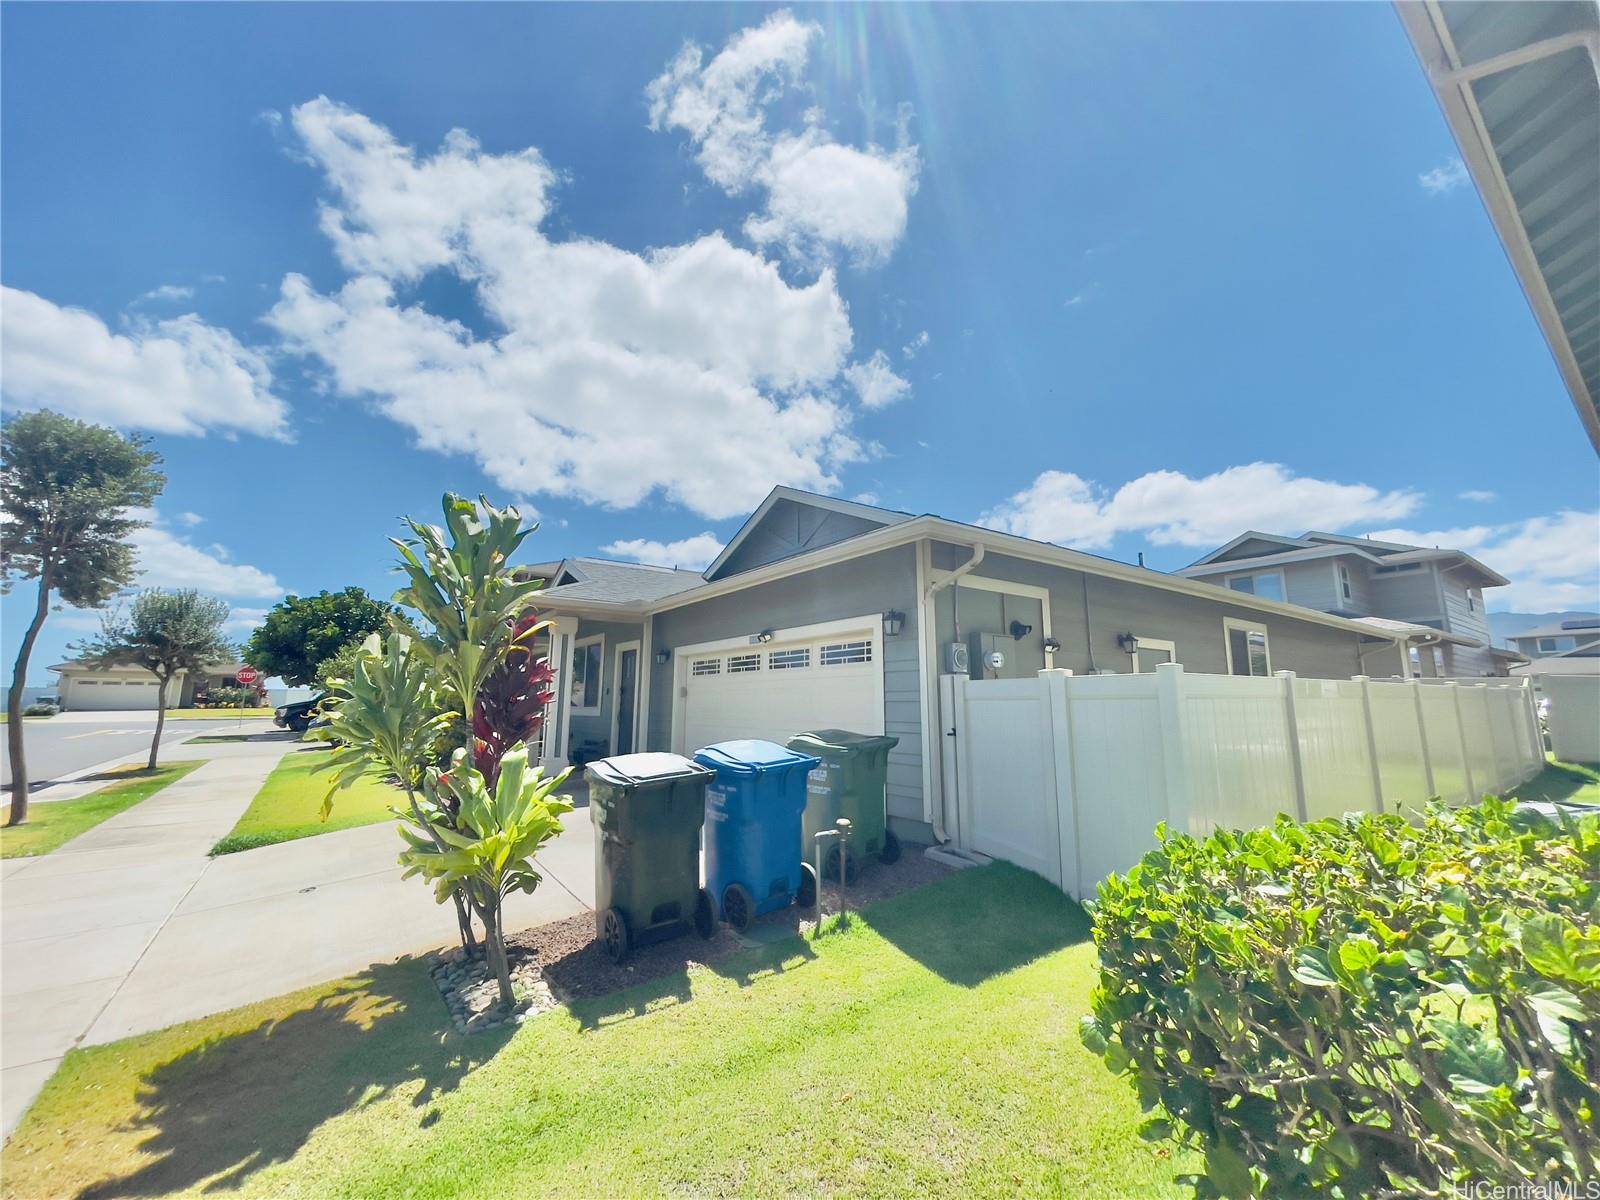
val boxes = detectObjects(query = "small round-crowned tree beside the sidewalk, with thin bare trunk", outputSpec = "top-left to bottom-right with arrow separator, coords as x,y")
77,587 -> 234,771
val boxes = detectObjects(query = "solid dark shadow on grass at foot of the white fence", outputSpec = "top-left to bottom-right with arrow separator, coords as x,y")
856,862 -> 1090,987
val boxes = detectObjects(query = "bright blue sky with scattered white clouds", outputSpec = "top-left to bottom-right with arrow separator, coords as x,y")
0,5 -> 1600,682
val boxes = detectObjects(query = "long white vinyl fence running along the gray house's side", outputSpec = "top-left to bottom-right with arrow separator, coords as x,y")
941,664 -> 1544,899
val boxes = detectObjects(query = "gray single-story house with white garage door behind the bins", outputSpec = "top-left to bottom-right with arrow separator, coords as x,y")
539,488 -> 1438,842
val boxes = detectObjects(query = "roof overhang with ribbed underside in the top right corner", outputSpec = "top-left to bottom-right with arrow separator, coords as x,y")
1395,0 -> 1600,451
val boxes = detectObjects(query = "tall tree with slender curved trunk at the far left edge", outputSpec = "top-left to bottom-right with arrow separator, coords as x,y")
0,411 -> 166,826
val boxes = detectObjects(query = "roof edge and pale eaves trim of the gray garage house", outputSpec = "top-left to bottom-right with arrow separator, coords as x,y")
538,488 -> 1414,642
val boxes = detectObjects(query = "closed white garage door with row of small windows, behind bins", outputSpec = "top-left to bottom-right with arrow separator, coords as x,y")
678,621 -> 883,754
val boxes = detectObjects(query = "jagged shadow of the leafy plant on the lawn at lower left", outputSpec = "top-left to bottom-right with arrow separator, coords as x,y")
78,960 -> 510,1200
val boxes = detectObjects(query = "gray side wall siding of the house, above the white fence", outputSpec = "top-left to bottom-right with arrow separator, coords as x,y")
933,542 -> 1360,678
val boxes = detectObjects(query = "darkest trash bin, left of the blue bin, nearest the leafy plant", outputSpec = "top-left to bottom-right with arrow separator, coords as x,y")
584,754 -> 717,962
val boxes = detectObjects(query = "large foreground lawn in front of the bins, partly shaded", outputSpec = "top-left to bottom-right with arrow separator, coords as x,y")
3,864 -> 1194,1200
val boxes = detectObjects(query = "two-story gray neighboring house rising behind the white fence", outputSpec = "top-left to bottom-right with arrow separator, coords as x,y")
1178,530 -> 1509,677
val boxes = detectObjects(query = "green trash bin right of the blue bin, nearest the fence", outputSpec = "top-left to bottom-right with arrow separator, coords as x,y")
789,730 -> 899,874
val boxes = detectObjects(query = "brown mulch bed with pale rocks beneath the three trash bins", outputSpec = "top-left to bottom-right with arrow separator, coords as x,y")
492,846 -> 950,1002
